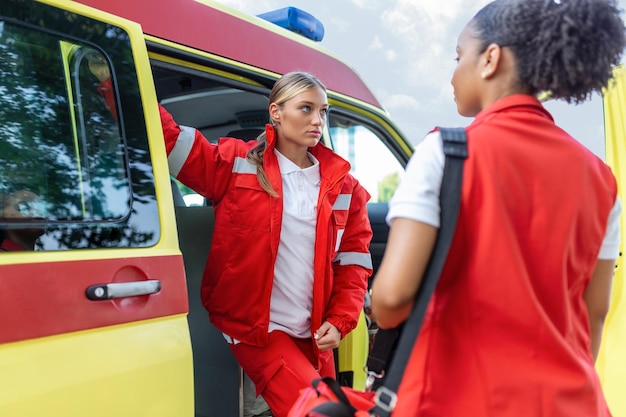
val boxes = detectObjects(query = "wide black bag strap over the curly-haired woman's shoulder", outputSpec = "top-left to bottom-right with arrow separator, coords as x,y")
373,127 -> 467,417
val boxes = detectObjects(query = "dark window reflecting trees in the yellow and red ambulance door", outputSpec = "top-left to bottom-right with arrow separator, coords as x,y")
0,16 -> 158,250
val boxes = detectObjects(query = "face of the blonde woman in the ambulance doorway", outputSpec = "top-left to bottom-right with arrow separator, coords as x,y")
270,87 -> 328,147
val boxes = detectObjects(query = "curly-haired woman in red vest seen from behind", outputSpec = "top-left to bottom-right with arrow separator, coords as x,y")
372,0 -> 625,417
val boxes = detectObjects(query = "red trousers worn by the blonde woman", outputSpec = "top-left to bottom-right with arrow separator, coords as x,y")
230,331 -> 335,417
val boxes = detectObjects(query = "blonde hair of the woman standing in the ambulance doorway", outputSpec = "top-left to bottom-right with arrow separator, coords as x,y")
246,72 -> 326,197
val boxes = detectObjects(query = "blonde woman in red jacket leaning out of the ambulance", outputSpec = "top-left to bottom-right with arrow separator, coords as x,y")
161,72 -> 372,417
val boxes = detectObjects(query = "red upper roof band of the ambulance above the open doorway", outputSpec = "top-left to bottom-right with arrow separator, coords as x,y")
77,0 -> 381,107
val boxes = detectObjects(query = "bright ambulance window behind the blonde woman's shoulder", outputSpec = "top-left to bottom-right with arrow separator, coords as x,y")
328,111 -> 404,202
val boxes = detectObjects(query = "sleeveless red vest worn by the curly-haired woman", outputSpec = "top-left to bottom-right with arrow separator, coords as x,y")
393,95 -> 617,417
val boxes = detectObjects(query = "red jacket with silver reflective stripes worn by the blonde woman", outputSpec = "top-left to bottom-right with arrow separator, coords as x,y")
160,107 -> 372,352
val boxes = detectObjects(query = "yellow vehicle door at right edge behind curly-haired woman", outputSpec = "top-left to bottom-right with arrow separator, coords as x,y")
596,67 -> 626,416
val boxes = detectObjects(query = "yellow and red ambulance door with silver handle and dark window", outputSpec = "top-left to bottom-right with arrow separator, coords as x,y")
0,0 -> 194,417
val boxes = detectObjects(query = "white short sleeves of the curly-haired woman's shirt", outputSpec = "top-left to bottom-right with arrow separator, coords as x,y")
387,131 -> 622,259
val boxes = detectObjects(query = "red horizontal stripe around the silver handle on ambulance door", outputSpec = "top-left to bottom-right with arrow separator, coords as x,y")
0,255 -> 188,344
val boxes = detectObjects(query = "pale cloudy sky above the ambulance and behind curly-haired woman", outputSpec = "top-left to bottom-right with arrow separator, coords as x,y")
217,0 -> 626,158
